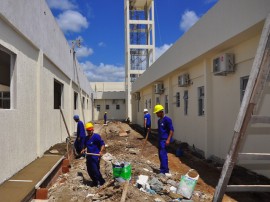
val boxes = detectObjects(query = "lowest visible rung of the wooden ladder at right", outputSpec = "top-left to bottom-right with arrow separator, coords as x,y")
227,185 -> 270,192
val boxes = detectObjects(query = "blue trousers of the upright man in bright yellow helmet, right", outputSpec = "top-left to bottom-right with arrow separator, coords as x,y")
158,140 -> 169,174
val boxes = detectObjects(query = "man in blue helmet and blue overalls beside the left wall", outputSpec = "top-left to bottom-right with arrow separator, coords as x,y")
73,115 -> 86,158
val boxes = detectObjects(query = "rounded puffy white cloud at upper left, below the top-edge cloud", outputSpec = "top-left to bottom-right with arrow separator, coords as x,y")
56,10 -> 88,32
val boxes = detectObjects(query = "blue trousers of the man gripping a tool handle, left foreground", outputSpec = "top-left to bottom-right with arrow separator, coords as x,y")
86,156 -> 105,186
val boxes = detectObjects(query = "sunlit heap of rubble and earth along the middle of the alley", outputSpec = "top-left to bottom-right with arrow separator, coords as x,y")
49,122 -> 217,202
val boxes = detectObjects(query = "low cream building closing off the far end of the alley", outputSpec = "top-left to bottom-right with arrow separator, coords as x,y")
90,82 -> 126,121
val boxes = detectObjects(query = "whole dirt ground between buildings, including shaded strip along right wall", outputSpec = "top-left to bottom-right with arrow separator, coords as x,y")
46,122 -> 270,202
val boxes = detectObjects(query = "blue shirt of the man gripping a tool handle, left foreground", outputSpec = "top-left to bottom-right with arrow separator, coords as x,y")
85,133 -> 105,154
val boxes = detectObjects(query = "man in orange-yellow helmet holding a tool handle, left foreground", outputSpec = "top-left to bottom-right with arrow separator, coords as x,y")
82,122 -> 105,187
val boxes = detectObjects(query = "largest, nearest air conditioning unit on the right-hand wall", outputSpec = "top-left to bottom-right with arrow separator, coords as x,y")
213,53 -> 234,76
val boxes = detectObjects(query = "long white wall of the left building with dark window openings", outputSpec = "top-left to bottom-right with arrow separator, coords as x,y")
0,0 -> 92,183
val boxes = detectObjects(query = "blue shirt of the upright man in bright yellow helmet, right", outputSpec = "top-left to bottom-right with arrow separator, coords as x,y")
158,116 -> 174,140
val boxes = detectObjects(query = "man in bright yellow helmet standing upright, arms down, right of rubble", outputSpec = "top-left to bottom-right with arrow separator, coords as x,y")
154,104 -> 174,174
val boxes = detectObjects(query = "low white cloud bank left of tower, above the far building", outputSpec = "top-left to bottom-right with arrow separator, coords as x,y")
80,61 -> 125,82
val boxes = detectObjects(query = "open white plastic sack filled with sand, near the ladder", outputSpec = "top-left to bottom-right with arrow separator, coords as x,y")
176,169 -> 199,199
